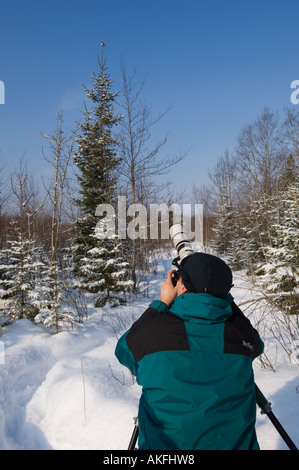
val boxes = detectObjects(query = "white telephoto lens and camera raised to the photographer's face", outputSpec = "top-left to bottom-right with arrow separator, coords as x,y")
169,224 -> 193,286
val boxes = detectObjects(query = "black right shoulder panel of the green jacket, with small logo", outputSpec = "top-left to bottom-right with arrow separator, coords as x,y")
224,303 -> 262,359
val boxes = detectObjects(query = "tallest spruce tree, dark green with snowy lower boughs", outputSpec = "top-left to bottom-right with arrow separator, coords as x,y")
73,46 -> 131,306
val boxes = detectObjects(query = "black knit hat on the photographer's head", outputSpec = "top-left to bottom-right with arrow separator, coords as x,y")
180,253 -> 233,299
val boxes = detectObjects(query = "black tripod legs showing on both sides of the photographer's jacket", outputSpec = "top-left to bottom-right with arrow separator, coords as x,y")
128,384 -> 298,450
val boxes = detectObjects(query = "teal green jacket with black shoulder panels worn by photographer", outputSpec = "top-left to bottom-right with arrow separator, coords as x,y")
115,293 -> 263,450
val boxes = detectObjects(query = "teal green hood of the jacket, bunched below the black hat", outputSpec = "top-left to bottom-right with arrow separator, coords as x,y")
169,293 -> 233,324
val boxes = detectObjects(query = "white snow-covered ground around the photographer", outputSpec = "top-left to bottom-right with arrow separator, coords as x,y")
0,252 -> 299,450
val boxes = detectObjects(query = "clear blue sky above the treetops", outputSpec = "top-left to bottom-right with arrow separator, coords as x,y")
0,0 -> 299,191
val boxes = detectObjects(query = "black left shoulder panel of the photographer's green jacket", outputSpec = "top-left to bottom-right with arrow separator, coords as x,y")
126,307 -> 190,362
